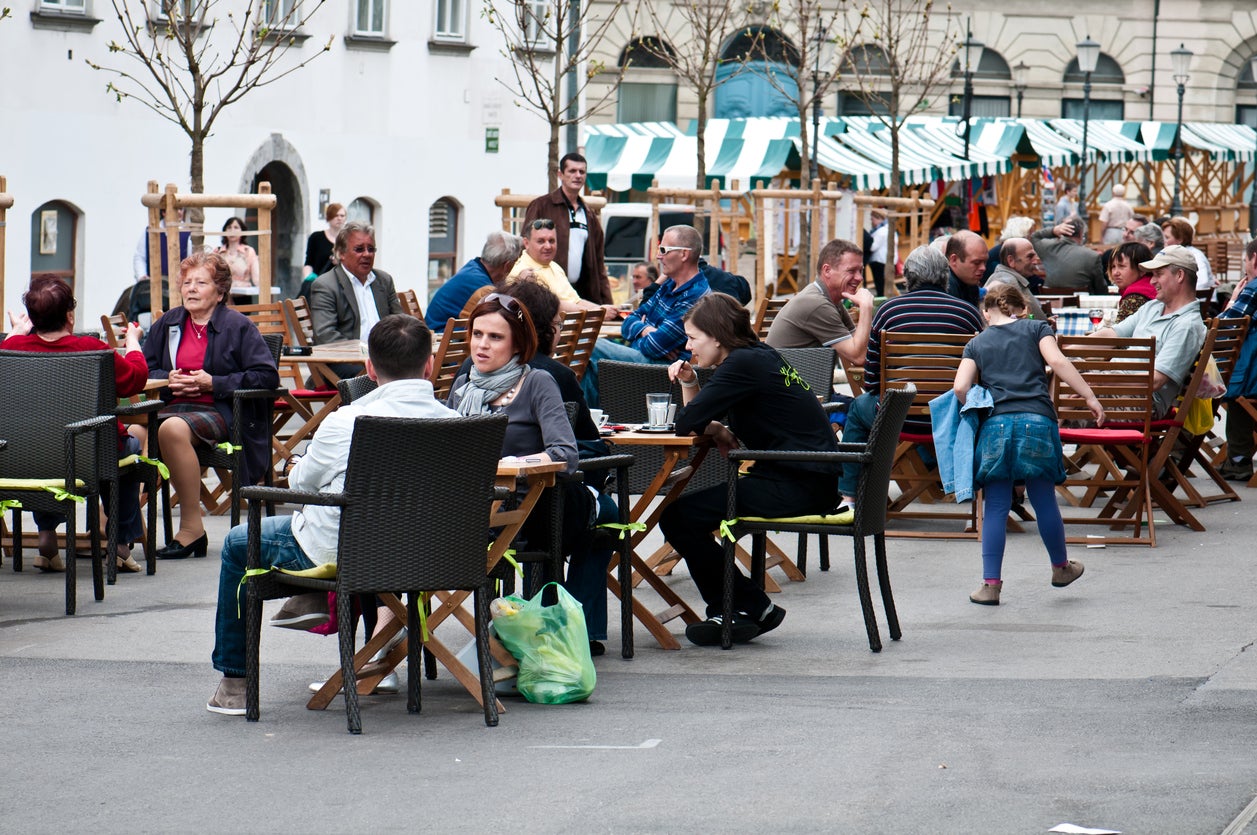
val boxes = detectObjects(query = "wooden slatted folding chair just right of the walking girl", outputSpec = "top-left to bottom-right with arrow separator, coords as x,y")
1052,336 -> 1156,546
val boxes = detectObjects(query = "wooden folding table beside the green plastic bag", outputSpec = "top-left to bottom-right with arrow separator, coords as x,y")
305,460 -> 564,713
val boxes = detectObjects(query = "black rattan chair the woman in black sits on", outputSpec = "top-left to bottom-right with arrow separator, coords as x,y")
722,385 -> 916,653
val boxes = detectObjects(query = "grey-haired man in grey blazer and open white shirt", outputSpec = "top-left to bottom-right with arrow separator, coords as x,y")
310,220 -> 402,377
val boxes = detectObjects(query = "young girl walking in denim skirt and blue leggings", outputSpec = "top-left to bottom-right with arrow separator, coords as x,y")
953,284 -> 1104,606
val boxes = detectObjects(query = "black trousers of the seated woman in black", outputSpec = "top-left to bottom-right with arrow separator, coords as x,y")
659,470 -> 838,619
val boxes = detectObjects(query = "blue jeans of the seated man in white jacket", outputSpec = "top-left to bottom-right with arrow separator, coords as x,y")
214,516 -> 314,677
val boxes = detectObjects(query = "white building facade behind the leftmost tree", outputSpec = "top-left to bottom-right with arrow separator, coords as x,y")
0,0 -> 547,319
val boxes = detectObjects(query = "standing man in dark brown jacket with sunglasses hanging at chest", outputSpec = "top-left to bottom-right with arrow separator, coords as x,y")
524,153 -> 613,304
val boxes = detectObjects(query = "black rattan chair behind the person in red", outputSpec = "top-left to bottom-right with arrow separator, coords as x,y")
0,351 -> 157,615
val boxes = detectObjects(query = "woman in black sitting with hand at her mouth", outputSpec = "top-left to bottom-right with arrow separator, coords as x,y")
660,293 -> 838,646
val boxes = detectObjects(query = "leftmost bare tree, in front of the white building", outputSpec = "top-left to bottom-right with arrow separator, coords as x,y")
87,0 -> 332,201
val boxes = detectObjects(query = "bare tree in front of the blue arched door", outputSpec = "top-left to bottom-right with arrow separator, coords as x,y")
629,0 -> 747,189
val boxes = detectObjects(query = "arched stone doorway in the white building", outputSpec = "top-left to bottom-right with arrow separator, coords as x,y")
240,133 -> 310,297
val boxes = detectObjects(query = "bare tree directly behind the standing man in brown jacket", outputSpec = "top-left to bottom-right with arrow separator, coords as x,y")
483,0 -> 625,191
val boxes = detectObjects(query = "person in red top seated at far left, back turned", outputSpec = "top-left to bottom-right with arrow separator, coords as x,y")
0,273 -> 148,571
